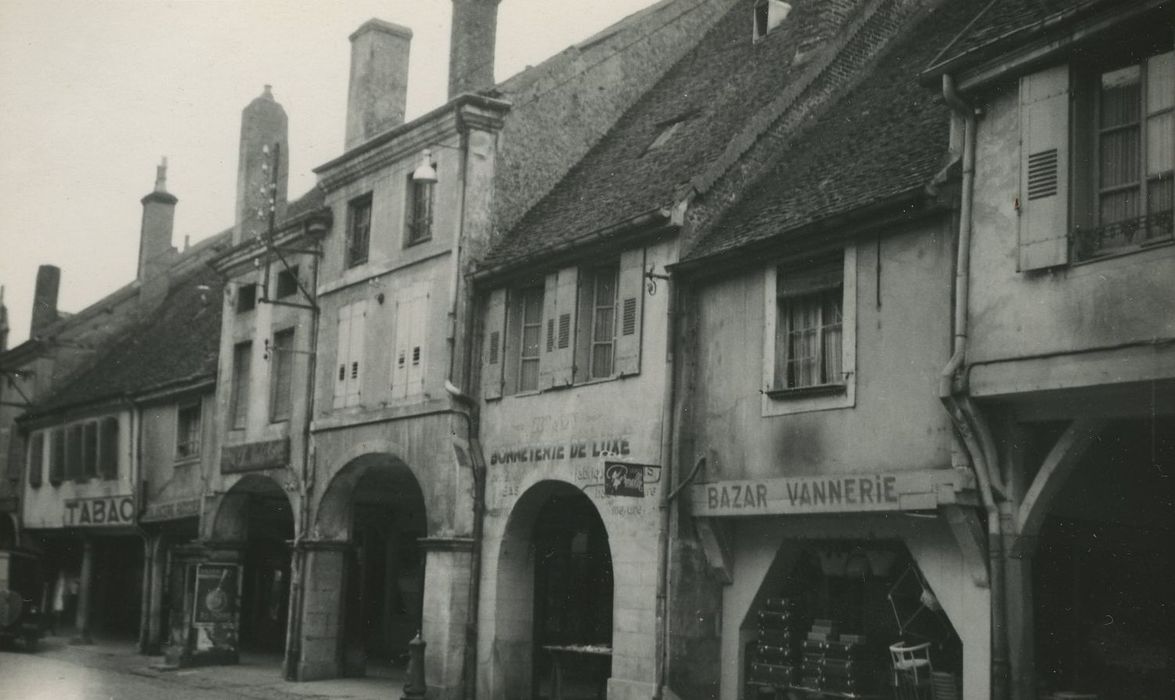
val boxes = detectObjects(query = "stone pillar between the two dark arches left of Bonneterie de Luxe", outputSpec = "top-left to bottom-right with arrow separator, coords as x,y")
297,541 -> 350,680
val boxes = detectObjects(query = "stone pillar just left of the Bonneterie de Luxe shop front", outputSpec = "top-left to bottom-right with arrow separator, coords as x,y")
419,537 -> 476,700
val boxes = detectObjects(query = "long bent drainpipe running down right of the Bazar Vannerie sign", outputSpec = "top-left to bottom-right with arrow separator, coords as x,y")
939,75 -> 1009,700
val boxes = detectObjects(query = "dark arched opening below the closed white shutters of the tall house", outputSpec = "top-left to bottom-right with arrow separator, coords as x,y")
318,455 -> 427,677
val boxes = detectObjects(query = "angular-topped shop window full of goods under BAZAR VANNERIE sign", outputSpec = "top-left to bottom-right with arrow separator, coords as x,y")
740,540 -> 962,700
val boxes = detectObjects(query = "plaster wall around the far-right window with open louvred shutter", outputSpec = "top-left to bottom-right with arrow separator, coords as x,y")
968,82 -> 1175,371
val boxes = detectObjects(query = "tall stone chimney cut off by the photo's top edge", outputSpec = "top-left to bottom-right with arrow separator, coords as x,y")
449,0 -> 499,97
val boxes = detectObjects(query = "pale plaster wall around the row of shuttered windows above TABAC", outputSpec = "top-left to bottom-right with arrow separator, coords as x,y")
21,410 -> 135,529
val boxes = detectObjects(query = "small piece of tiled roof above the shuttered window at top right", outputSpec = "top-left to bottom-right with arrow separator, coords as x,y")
928,0 -> 1118,77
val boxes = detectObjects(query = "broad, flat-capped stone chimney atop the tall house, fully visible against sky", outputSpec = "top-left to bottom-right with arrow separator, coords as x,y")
344,19 -> 412,149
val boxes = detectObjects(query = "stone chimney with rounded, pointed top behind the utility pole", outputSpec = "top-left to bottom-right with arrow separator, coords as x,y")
233,85 -> 289,243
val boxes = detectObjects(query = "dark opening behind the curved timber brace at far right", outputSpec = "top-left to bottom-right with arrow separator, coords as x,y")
1033,418 -> 1175,700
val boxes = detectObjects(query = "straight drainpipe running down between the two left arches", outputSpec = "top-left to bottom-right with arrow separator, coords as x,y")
282,230 -> 322,680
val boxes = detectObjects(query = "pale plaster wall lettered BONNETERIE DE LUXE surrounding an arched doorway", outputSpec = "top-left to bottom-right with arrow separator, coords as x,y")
477,242 -> 676,700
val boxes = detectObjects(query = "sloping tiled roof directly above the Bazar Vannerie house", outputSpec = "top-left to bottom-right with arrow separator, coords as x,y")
683,0 -> 975,261
